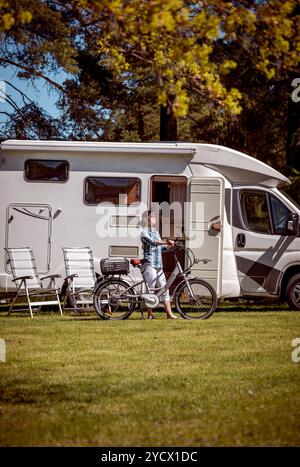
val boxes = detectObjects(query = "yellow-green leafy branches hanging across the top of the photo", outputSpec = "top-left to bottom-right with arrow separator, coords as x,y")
69,0 -> 299,139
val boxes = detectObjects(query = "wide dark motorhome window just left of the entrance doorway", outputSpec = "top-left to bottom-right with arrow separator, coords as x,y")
84,177 -> 141,205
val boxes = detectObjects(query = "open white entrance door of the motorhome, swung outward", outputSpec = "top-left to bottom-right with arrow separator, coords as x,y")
185,177 -> 224,295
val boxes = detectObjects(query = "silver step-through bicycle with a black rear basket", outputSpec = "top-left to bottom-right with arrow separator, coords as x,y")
93,242 -> 217,320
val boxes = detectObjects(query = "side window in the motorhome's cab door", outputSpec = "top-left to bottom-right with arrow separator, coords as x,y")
242,193 -> 271,234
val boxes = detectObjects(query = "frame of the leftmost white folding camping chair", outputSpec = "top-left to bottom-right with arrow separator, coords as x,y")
5,247 -> 63,318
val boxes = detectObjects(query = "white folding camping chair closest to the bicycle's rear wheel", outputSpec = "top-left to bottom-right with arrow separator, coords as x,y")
63,247 -> 97,312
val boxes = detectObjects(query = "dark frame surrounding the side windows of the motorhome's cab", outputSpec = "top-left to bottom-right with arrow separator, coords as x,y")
239,189 -> 292,236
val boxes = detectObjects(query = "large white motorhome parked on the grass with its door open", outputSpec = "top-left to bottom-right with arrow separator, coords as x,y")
0,140 -> 300,309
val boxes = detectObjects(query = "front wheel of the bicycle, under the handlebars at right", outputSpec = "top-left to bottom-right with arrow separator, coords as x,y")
175,279 -> 217,319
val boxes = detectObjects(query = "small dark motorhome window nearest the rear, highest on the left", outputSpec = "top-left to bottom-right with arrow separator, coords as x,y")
24,159 -> 69,183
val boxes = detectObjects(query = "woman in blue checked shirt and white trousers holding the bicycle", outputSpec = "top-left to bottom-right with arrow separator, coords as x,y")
141,211 -> 178,319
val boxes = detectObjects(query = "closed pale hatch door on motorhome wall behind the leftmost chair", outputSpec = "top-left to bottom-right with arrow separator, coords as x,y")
5,203 -> 52,274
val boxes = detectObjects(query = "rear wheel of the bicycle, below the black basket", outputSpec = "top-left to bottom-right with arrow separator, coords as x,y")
93,278 -> 135,320
